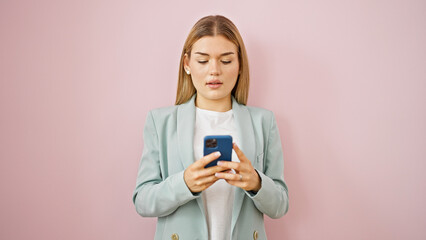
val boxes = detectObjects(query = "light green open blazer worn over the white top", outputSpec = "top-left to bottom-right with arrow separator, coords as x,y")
133,95 -> 288,240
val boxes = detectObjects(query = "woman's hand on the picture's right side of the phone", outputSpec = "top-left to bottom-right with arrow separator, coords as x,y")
215,143 -> 261,192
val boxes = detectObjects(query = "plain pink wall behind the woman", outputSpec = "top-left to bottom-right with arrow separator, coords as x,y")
0,0 -> 426,240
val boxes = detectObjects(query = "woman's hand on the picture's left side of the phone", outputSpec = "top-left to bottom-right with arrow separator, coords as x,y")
183,152 -> 228,193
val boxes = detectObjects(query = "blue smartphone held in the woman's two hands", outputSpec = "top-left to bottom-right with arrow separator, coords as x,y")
204,135 -> 232,168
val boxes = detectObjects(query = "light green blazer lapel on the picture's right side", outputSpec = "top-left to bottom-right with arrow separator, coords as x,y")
232,97 -> 256,229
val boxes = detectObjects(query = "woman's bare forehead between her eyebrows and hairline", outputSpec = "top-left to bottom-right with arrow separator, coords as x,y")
191,35 -> 237,55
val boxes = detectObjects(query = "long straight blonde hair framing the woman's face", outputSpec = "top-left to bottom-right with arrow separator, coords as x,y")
175,15 -> 250,105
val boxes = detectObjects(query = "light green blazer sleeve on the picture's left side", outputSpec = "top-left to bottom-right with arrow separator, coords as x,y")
133,112 -> 199,217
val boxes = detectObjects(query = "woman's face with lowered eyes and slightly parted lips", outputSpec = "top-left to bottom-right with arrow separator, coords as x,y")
184,35 -> 239,105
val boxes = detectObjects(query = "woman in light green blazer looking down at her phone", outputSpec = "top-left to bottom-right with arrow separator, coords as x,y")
133,16 -> 288,240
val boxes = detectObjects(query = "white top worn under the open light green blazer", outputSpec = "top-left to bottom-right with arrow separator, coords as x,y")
194,107 -> 239,240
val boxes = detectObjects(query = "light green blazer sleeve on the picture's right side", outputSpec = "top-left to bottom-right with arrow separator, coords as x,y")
246,112 -> 289,218
